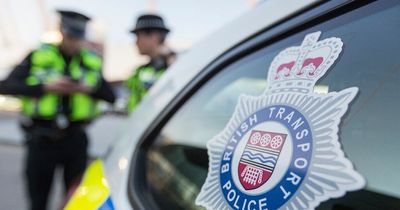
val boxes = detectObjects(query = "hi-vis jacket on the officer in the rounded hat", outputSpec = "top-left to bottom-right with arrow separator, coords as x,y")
125,66 -> 165,112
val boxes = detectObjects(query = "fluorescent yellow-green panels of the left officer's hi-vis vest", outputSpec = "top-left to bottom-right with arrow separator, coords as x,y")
22,45 -> 102,122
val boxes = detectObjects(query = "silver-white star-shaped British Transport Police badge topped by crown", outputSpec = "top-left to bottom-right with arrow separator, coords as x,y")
196,32 -> 365,210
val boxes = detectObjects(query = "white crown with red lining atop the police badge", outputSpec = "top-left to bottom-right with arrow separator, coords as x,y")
266,31 -> 343,93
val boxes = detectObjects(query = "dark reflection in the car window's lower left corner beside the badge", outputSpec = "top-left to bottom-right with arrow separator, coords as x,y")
147,145 -> 208,210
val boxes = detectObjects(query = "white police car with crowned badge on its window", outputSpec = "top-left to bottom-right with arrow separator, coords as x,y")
66,0 -> 400,210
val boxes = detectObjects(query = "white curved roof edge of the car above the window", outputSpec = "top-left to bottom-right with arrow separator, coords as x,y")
105,0 -> 318,207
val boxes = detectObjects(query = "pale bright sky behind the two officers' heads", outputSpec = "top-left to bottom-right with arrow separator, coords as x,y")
0,0 -> 257,80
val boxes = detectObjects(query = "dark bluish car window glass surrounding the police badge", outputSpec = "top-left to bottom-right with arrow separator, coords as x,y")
146,1 -> 400,209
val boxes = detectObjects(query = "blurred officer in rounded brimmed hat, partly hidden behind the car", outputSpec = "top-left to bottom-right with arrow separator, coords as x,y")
125,14 -> 176,112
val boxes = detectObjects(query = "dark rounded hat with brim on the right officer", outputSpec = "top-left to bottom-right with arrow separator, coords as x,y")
130,14 -> 169,33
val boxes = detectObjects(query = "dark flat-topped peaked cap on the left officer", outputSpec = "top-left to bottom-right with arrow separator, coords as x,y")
57,10 -> 90,39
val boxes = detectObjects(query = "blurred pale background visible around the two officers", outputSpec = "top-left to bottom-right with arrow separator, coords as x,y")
0,0 -> 259,209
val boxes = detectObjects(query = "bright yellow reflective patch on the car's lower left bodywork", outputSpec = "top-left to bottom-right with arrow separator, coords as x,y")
64,160 -> 110,210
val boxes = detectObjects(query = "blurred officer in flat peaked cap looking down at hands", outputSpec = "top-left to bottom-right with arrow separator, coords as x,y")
0,11 -> 115,210
